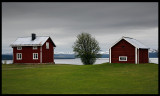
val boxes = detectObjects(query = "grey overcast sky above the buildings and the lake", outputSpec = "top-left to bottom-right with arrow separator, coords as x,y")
2,2 -> 158,53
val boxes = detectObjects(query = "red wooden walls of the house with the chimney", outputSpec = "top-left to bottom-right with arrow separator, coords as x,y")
13,38 -> 54,63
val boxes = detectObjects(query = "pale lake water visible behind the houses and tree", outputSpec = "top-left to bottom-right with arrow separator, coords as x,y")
2,58 -> 158,65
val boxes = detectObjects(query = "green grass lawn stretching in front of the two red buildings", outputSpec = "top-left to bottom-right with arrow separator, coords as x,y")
2,63 -> 158,94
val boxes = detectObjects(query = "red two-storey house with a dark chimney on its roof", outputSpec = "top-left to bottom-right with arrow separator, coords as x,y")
11,34 -> 56,63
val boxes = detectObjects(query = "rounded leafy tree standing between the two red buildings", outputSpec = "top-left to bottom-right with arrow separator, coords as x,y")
73,33 -> 100,65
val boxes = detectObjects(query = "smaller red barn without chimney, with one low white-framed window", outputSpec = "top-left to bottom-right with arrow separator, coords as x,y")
109,37 -> 149,64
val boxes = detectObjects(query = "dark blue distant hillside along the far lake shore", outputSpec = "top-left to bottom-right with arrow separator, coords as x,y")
2,53 -> 158,60
